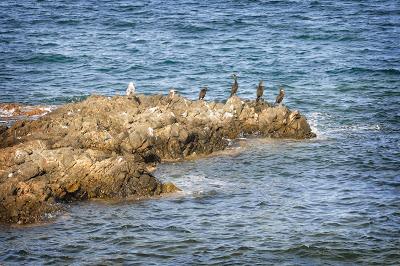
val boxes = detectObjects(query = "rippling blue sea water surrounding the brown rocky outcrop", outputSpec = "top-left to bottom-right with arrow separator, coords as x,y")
0,0 -> 400,265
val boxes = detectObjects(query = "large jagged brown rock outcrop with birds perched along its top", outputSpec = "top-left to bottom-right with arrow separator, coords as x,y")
0,95 -> 314,223
